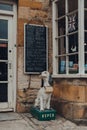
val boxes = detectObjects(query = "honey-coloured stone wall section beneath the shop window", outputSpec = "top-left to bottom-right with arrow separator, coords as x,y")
52,78 -> 87,121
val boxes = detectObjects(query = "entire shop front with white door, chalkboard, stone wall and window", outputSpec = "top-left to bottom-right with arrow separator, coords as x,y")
0,0 -> 87,120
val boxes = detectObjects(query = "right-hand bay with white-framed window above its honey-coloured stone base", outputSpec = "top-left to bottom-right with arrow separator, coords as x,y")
52,0 -> 87,120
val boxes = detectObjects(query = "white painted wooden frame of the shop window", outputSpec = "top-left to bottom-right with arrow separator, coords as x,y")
52,0 -> 87,78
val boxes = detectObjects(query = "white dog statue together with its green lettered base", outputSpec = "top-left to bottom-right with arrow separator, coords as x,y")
31,71 -> 56,121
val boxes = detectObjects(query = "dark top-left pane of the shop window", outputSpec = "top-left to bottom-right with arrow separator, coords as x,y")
58,0 -> 65,17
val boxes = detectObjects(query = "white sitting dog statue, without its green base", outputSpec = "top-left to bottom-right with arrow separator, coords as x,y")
34,71 -> 53,111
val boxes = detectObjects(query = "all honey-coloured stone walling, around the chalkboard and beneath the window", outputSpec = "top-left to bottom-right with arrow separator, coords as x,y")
16,0 -> 87,120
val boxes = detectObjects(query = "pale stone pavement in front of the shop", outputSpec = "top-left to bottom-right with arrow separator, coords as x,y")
0,112 -> 87,130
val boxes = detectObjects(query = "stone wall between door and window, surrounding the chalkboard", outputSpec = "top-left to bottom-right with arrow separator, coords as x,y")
16,0 -> 52,112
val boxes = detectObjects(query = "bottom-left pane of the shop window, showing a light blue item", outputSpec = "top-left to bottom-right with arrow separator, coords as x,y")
58,57 -> 66,74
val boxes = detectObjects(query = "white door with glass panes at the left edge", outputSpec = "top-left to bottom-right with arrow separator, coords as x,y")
0,16 -> 12,109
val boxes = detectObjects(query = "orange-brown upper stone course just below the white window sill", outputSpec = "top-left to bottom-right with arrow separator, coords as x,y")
54,80 -> 85,102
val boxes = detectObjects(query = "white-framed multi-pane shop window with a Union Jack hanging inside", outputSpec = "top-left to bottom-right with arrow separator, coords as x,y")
53,0 -> 87,76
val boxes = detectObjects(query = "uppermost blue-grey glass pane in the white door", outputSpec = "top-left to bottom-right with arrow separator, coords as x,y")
0,19 -> 8,39
